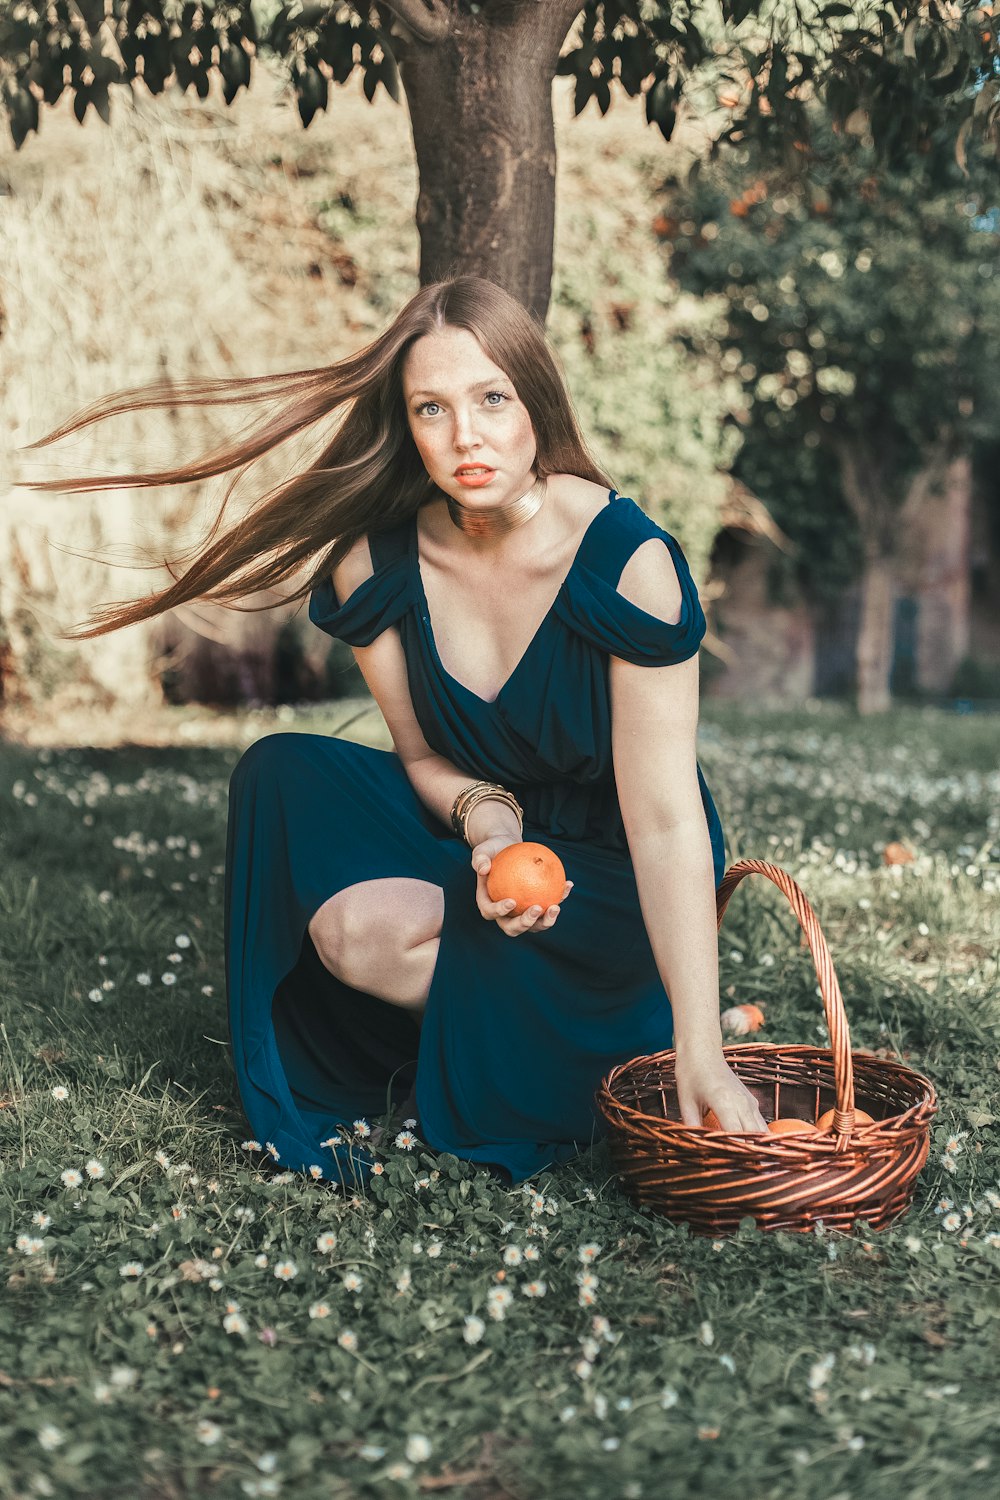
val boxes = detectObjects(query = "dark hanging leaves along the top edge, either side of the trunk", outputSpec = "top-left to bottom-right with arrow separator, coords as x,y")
0,0 -> 1000,167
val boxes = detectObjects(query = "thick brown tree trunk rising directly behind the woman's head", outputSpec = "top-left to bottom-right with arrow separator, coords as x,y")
400,0 -> 579,323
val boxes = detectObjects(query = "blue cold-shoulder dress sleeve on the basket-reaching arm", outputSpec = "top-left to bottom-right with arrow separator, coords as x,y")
556,500 -> 705,666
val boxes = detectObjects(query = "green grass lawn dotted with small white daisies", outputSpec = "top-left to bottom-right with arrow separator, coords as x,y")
0,705 -> 1000,1500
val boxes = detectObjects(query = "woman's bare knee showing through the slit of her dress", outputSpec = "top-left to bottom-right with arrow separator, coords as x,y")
309,876 -> 444,1013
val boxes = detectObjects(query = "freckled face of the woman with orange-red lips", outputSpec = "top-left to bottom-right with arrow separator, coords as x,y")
403,329 -> 535,510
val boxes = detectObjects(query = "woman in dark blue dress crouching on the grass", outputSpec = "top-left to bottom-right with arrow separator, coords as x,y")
29,276 -> 765,1182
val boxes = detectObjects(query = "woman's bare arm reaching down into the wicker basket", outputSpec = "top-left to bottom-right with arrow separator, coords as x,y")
610,539 -> 765,1130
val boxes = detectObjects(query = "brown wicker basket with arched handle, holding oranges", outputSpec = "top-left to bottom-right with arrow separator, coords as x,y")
595,860 -> 937,1235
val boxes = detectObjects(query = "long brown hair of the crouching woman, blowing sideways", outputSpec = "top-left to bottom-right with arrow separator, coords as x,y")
24,276 -> 610,641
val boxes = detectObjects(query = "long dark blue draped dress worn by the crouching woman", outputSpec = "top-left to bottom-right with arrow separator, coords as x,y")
225,491 -> 724,1185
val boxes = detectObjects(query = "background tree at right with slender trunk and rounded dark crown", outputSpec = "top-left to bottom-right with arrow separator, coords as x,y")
658,110 -> 1000,713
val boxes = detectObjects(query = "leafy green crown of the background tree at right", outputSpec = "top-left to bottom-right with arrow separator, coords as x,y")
660,111 -> 1000,516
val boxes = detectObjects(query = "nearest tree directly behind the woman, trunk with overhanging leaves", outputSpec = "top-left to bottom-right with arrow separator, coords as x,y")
0,0 -> 1000,318
